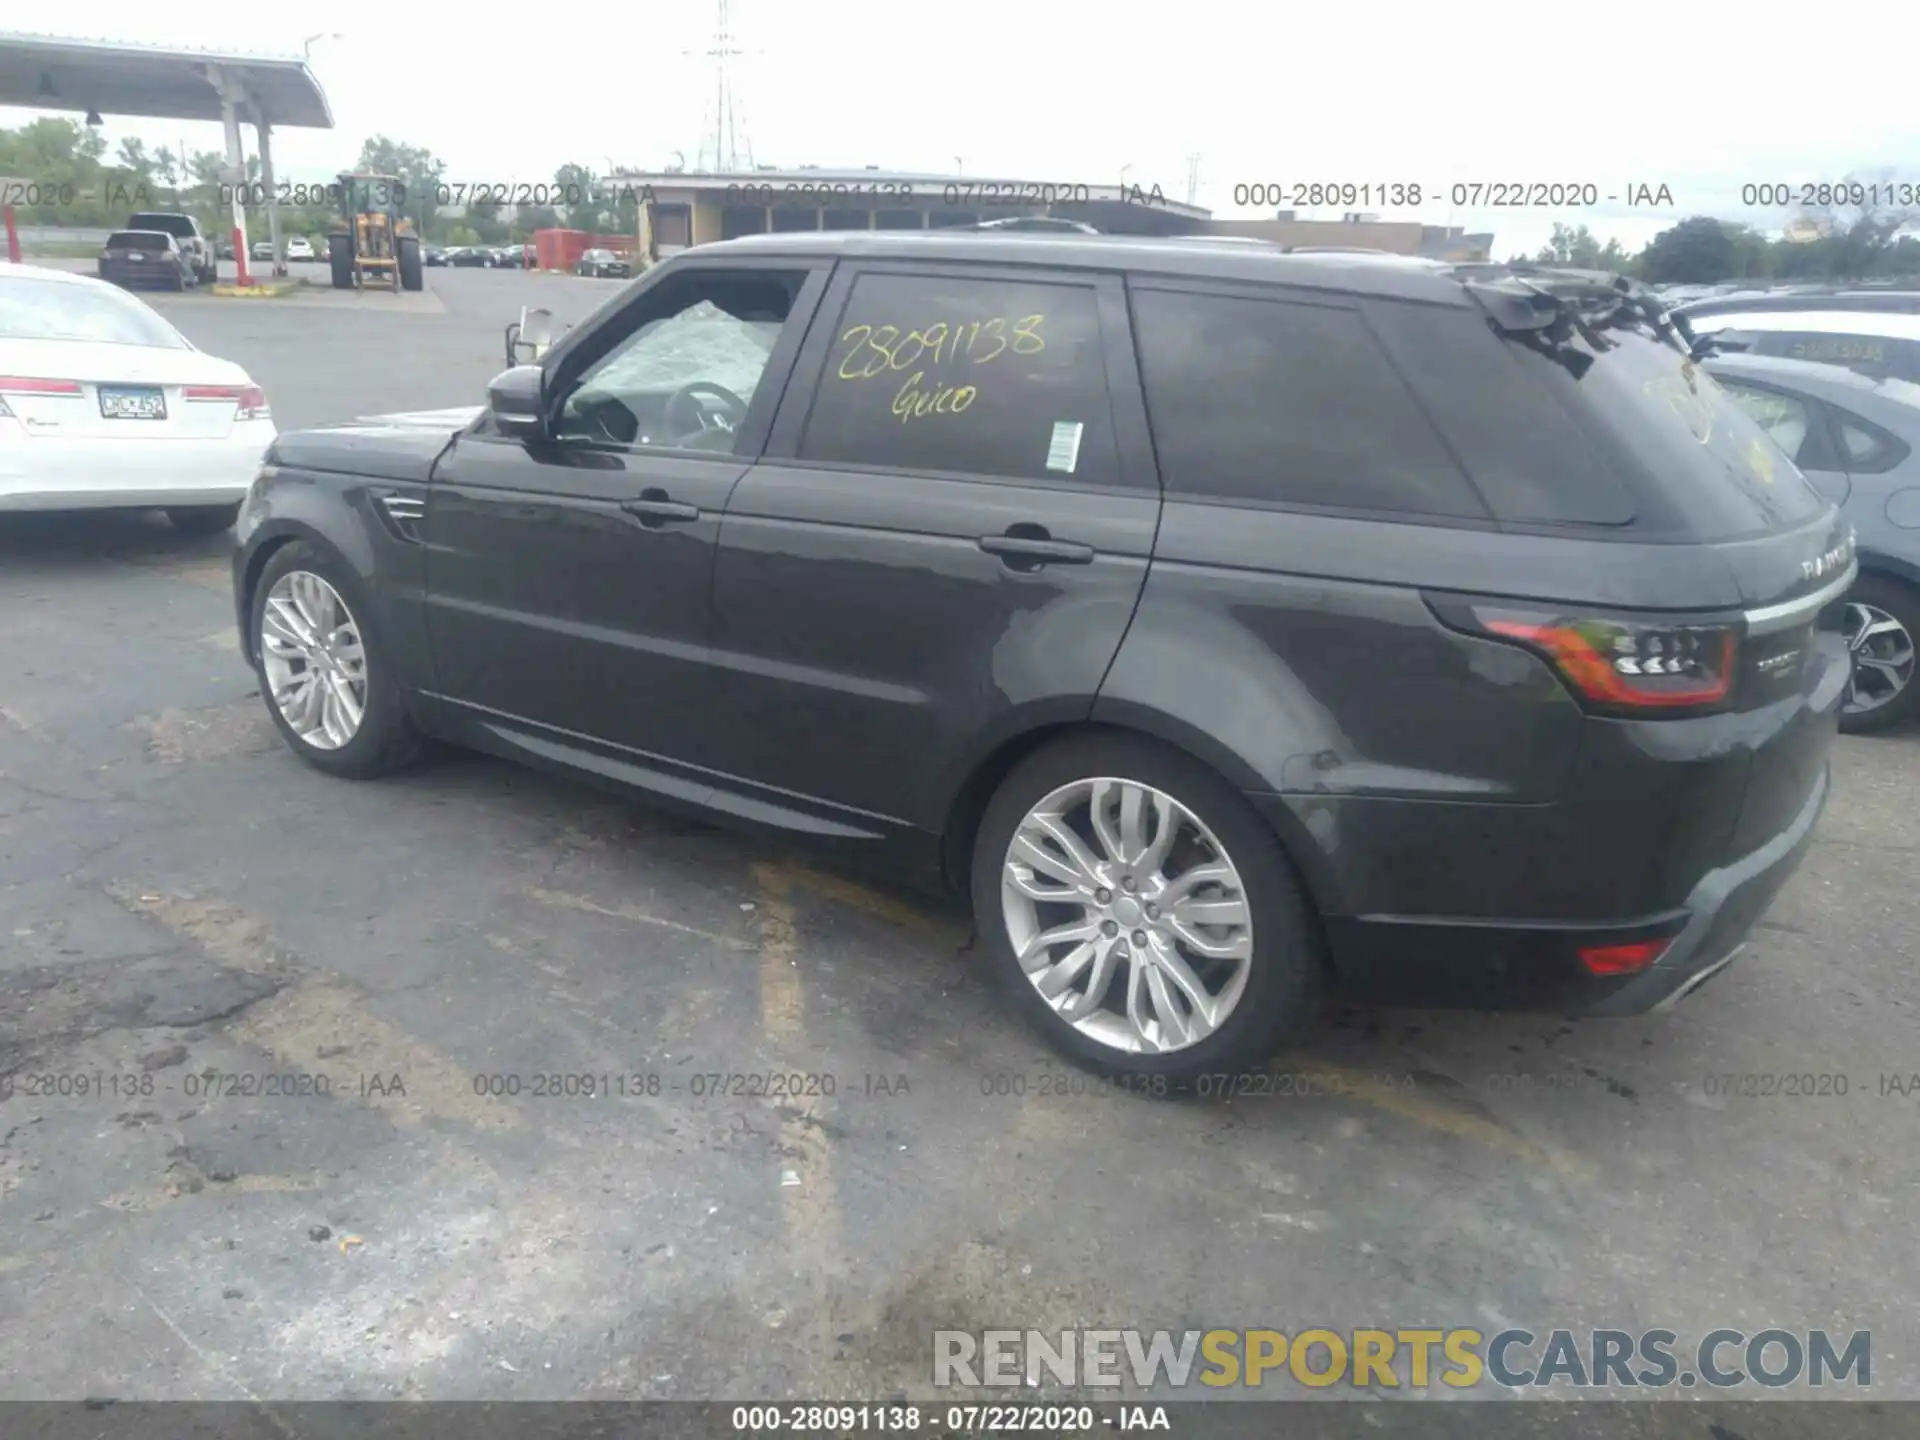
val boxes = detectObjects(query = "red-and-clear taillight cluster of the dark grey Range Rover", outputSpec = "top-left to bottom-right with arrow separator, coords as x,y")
1446,603 -> 1741,714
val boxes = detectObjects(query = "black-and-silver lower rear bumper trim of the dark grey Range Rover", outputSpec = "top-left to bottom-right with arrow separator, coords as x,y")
1325,766 -> 1832,1016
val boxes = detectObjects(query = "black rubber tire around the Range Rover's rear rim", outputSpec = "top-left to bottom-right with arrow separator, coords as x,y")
972,732 -> 1327,1085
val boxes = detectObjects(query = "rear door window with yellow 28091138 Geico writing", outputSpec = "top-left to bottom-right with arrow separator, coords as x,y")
799,273 -> 1119,484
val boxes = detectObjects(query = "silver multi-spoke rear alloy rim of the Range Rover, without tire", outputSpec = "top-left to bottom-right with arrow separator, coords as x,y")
1000,776 -> 1254,1054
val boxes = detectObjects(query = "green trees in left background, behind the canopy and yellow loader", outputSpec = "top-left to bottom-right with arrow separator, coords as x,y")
0,117 -> 639,246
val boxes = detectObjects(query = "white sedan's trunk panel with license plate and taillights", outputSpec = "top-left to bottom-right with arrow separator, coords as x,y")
0,340 -> 265,440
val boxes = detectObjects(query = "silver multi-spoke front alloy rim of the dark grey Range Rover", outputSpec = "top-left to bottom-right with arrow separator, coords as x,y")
259,570 -> 367,751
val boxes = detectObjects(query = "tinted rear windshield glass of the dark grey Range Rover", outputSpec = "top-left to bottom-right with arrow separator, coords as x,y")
1482,311 -> 1826,540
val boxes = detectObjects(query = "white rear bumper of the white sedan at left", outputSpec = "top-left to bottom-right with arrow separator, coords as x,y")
0,420 -> 275,511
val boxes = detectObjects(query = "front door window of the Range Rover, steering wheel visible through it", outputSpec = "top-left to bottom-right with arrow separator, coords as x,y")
555,271 -> 806,453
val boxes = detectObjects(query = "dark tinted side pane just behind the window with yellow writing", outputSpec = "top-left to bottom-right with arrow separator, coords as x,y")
1133,288 -> 1488,520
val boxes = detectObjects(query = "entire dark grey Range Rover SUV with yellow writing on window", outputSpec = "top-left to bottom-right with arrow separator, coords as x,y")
234,232 -> 1857,1077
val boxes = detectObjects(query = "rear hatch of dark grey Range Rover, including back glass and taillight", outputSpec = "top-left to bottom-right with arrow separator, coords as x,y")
1469,276 -> 1855,858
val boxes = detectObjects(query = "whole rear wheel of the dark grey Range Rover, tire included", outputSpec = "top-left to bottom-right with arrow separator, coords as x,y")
972,733 -> 1325,1081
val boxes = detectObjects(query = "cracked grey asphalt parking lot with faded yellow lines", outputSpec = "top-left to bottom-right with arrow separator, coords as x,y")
0,267 -> 1920,1400
